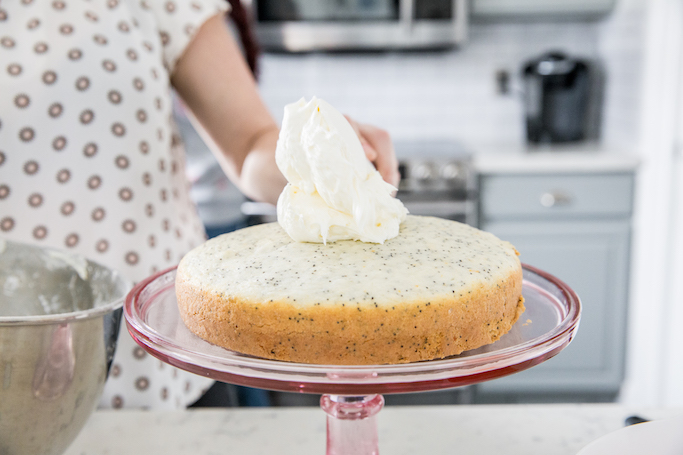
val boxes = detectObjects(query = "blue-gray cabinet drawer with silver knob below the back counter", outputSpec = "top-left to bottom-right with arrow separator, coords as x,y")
480,174 -> 633,219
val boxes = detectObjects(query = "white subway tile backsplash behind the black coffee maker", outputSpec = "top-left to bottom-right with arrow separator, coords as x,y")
260,0 -> 645,153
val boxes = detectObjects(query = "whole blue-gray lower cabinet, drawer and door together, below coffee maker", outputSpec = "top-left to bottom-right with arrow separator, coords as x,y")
475,171 -> 634,402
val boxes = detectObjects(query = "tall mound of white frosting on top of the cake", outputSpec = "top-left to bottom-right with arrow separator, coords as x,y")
275,97 -> 408,243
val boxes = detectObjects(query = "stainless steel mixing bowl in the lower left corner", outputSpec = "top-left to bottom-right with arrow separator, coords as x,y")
0,239 -> 130,455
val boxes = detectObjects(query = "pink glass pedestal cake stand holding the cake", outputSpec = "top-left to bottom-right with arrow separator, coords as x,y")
124,265 -> 581,455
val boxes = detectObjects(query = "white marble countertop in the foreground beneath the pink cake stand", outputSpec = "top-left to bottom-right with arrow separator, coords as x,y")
66,404 -> 683,455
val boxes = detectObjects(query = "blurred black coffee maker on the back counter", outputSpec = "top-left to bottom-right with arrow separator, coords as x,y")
522,52 -> 600,144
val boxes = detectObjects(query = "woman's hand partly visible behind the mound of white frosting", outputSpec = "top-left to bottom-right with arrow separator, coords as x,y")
345,115 -> 401,188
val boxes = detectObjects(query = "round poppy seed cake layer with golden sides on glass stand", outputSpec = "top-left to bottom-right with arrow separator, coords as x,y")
176,216 -> 524,365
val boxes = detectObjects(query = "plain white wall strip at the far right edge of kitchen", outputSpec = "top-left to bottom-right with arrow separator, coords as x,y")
622,0 -> 683,406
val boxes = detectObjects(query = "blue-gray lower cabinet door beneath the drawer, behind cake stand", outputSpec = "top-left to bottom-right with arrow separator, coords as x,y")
479,219 -> 630,394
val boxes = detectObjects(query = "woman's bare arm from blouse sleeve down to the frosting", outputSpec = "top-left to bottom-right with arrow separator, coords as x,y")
171,15 -> 287,203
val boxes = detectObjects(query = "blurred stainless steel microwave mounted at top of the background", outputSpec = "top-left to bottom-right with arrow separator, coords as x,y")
251,0 -> 468,52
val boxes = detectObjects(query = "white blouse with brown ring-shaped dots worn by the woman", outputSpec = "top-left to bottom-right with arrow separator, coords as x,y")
0,0 -> 227,408
